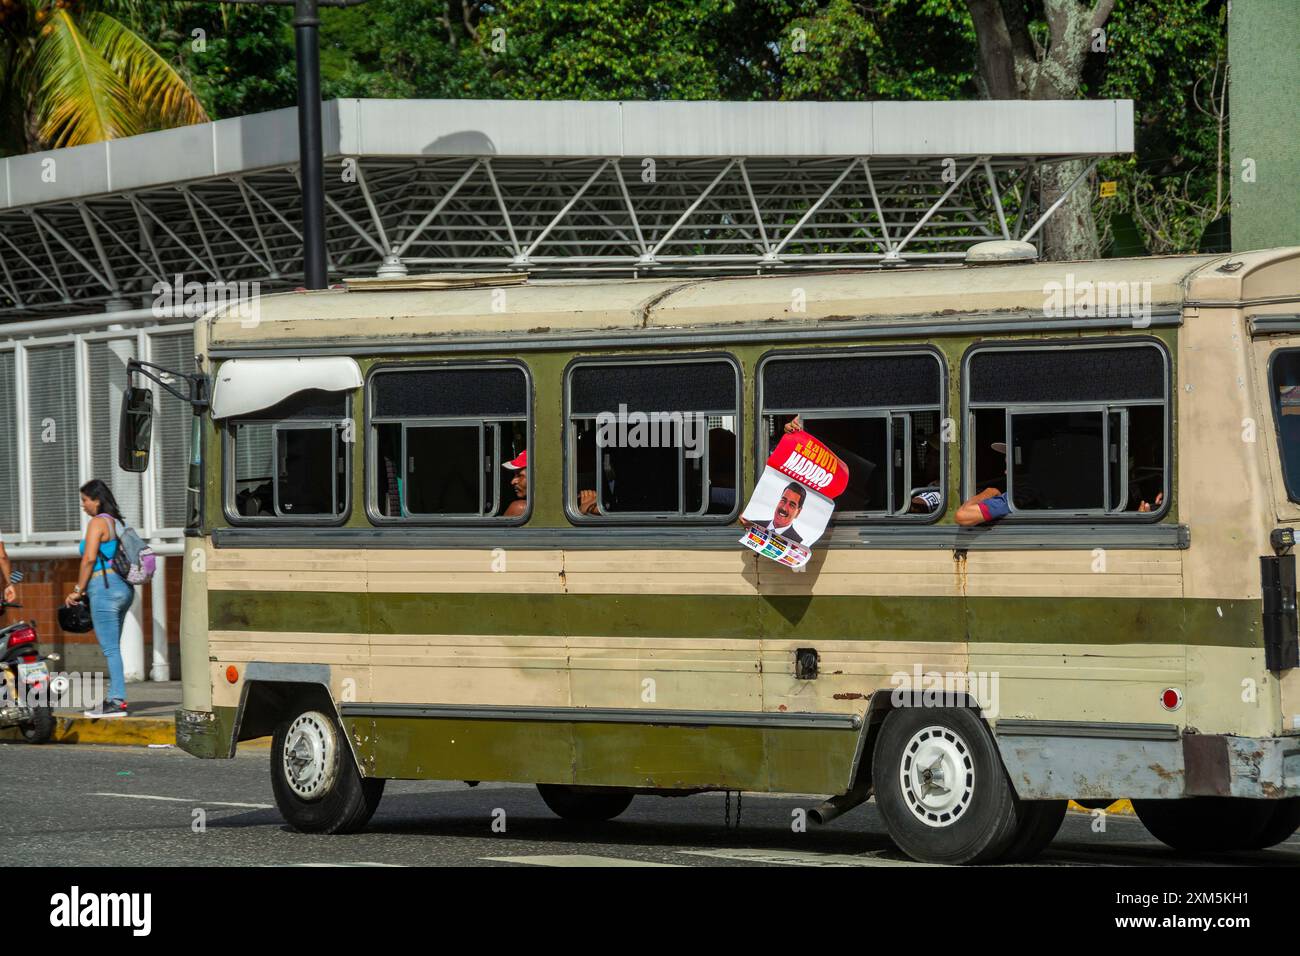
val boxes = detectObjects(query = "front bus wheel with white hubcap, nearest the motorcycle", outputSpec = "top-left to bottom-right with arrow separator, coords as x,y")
270,705 -> 384,834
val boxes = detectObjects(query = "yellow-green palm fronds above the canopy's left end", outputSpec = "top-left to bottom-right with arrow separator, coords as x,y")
0,0 -> 208,153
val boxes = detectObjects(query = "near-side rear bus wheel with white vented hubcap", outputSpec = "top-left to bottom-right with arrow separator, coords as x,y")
871,708 -> 1018,864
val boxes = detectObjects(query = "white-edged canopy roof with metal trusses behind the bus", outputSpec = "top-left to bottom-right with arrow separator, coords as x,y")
0,100 -> 1134,321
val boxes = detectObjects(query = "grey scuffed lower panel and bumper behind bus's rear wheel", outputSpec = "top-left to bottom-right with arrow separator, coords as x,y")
996,721 -> 1300,800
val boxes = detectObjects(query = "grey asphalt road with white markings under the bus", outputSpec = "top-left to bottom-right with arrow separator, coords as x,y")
0,744 -> 1300,866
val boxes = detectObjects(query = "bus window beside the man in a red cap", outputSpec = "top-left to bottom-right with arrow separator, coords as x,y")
368,364 -> 532,522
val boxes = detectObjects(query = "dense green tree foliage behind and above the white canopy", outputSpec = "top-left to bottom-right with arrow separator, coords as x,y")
76,0 -> 1227,252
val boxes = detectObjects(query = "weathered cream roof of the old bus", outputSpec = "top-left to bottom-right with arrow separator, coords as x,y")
208,248 -> 1300,349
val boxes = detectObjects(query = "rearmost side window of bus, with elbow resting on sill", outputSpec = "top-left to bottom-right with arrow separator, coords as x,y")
966,342 -> 1169,516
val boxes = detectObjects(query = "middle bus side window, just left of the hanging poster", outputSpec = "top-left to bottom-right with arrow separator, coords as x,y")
567,359 -> 740,522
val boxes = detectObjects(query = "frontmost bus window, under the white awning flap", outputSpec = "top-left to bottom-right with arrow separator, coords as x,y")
228,390 -> 351,522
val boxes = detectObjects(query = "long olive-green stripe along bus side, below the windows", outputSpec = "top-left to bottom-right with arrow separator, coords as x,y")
208,591 -> 1262,648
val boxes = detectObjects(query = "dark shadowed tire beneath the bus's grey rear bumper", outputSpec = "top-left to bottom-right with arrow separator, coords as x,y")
1134,797 -> 1275,853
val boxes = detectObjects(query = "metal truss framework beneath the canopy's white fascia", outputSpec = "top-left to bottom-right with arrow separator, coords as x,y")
0,155 -> 1097,320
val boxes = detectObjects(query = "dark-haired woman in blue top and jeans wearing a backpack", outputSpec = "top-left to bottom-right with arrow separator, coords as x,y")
64,479 -> 135,717
